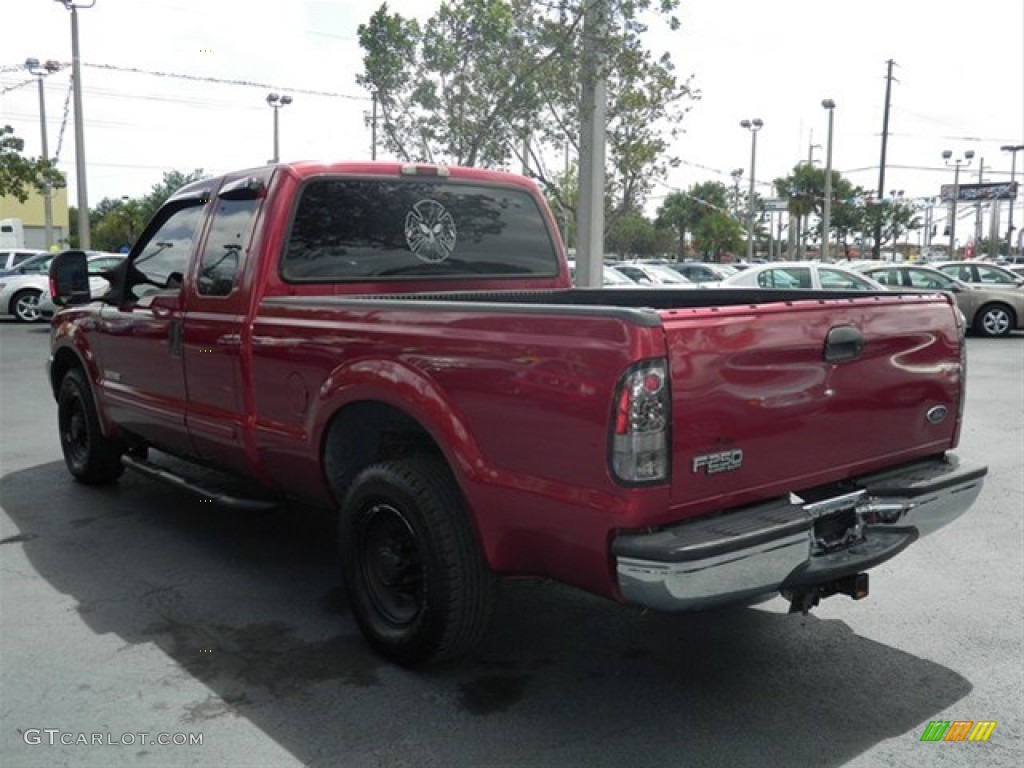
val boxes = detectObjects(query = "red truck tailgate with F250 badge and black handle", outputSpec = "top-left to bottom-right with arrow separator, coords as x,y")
660,295 -> 962,519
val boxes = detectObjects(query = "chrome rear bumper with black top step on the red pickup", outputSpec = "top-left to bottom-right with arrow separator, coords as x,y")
611,456 -> 988,611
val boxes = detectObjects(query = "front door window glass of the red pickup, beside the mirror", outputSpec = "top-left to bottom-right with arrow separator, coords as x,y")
129,201 -> 206,299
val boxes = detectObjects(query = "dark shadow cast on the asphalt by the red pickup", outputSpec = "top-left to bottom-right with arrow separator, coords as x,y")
0,463 -> 971,768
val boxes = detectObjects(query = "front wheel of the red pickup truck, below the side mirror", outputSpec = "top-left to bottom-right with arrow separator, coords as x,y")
57,369 -> 124,485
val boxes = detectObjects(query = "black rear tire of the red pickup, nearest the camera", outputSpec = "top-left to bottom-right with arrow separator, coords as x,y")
338,457 -> 497,667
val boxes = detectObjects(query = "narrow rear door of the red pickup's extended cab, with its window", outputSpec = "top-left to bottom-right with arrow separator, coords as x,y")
183,176 -> 265,470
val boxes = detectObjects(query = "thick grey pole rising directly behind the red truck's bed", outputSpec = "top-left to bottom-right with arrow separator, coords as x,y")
577,0 -> 608,288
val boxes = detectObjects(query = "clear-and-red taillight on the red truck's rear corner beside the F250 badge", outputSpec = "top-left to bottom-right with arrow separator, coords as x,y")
610,359 -> 672,485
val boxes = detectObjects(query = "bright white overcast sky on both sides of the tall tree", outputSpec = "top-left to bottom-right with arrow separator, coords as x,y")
0,0 -> 1024,237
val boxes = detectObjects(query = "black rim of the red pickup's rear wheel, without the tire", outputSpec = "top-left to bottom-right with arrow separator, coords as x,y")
358,504 -> 424,628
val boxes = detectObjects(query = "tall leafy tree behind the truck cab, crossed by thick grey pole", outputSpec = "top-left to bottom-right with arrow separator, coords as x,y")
356,0 -> 698,222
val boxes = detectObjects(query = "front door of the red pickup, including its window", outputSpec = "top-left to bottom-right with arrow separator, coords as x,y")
97,190 -> 209,456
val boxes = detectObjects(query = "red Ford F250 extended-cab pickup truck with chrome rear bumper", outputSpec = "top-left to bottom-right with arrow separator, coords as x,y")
48,163 -> 986,665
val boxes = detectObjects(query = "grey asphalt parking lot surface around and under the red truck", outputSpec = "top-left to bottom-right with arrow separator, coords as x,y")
0,321 -> 1024,768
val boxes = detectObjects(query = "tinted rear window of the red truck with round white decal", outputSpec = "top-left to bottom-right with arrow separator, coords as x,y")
281,179 -> 558,283
